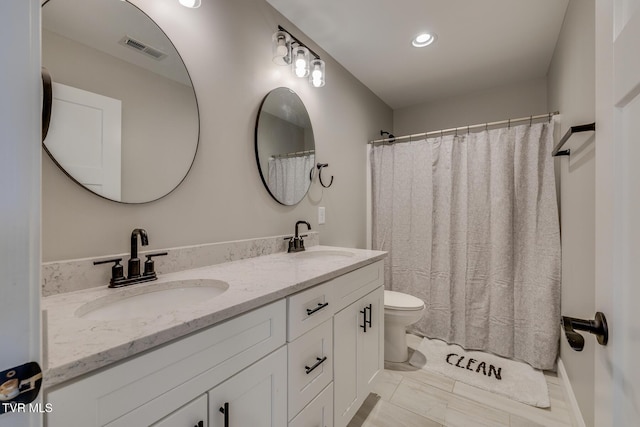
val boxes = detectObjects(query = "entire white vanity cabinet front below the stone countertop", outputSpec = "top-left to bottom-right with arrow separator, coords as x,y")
44,261 -> 384,427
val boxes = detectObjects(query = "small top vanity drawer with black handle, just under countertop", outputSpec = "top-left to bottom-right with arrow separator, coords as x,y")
287,281 -> 335,342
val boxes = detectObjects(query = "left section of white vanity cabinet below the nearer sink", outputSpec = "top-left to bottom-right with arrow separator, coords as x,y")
45,300 -> 287,427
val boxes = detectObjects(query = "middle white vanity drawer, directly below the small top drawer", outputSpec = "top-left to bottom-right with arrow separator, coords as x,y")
287,319 -> 333,419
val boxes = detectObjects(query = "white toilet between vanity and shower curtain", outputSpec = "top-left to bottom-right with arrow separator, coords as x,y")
384,290 -> 425,362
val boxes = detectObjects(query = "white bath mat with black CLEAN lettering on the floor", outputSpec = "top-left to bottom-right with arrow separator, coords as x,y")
409,338 -> 550,408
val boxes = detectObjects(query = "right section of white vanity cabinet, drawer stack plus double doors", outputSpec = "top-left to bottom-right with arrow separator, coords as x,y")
287,261 -> 384,427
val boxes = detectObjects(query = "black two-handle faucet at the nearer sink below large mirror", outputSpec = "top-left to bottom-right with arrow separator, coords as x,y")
93,228 -> 167,288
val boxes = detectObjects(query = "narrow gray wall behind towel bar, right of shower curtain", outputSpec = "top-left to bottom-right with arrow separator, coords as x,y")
548,0 -> 597,426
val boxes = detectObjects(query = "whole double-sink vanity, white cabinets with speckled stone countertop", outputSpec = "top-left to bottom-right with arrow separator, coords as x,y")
43,246 -> 385,427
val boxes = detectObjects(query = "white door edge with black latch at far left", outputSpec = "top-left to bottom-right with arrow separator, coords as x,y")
0,0 -> 42,427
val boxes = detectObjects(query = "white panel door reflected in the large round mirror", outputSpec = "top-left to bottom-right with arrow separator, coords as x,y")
45,82 -> 122,200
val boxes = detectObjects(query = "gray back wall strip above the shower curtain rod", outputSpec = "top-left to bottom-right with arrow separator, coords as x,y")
393,78 -> 548,136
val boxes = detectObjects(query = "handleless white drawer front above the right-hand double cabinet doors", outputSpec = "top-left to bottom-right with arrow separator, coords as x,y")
328,261 -> 384,313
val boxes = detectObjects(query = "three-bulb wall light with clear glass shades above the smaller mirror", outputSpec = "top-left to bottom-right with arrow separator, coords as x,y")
272,25 -> 325,87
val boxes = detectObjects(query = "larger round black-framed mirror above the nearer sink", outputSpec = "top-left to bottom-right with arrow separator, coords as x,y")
42,0 -> 200,203
